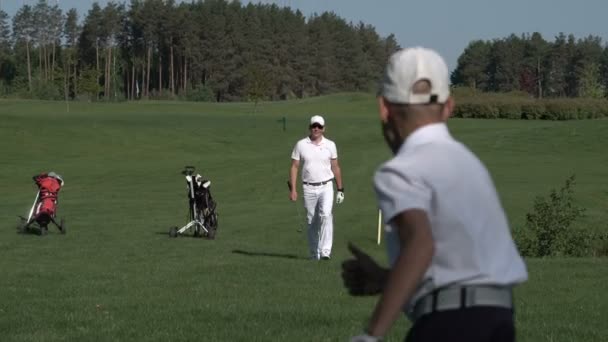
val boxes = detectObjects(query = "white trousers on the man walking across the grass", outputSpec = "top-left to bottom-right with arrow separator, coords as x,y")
303,182 -> 334,259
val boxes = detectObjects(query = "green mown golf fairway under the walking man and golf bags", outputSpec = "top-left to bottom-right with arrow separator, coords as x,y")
0,94 -> 608,341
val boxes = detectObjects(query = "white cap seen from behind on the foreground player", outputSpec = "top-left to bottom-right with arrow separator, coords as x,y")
379,47 -> 450,104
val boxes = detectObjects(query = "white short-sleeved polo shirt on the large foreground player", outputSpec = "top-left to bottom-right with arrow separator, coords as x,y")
374,123 -> 528,311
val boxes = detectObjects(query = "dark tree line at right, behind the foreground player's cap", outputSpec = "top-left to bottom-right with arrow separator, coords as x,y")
451,32 -> 608,98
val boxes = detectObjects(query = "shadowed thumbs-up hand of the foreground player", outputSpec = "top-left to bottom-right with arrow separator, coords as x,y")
342,243 -> 388,296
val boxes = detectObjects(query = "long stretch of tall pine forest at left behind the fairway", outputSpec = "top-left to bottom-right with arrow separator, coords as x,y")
0,0 -> 399,101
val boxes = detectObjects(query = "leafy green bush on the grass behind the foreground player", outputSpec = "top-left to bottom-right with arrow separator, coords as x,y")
515,176 -> 595,257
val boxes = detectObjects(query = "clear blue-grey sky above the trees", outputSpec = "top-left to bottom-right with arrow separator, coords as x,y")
0,0 -> 608,69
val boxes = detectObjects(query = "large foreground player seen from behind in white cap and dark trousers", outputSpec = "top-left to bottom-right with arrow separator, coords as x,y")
342,48 -> 527,342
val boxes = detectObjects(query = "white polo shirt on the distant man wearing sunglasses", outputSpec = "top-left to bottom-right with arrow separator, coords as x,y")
291,137 -> 338,183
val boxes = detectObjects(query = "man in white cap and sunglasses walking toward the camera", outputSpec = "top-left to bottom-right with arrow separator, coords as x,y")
289,115 -> 344,260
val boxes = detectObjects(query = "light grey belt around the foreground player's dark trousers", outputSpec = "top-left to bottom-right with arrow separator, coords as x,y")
410,285 -> 513,321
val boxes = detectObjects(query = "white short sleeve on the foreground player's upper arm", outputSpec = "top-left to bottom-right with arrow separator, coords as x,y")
374,165 -> 433,223
